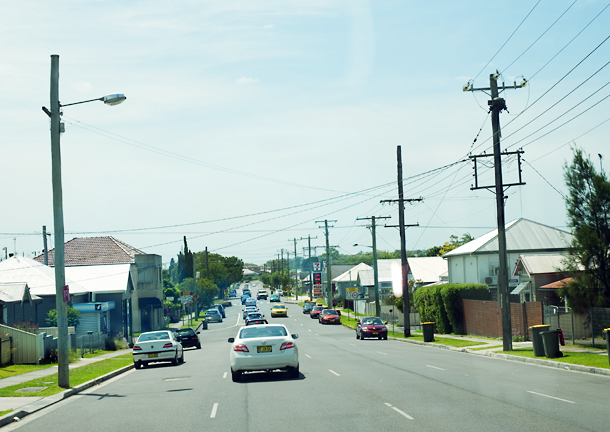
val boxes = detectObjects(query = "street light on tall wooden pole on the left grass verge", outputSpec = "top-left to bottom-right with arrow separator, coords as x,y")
42,54 -> 126,388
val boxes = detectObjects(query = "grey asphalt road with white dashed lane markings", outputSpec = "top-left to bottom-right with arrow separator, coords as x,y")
5,287 -> 610,432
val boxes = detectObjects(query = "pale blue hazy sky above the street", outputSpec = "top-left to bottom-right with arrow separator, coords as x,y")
0,0 -> 610,264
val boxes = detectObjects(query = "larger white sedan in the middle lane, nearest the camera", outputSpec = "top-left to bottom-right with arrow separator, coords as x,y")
229,324 -> 299,381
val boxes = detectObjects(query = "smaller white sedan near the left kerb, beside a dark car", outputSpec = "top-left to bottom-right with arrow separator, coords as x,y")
133,330 -> 184,369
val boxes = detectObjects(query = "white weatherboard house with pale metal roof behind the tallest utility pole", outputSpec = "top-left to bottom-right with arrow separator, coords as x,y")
443,219 -> 572,300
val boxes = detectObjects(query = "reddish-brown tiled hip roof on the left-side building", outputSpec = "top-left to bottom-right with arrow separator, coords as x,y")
34,236 -> 144,267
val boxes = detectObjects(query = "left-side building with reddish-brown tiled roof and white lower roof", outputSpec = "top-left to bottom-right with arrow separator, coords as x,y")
34,236 -> 164,335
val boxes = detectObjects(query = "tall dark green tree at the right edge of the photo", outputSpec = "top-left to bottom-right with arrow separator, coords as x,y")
560,147 -> 610,313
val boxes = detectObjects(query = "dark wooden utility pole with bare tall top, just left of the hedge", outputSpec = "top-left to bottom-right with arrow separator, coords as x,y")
381,146 -> 424,337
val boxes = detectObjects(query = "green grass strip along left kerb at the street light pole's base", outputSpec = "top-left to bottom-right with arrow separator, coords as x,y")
0,354 -> 133,397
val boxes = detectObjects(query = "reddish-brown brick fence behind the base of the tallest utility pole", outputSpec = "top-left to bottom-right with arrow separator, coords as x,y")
463,300 -> 544,340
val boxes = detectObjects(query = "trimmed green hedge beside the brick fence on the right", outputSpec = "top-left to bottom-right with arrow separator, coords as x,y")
413,284 -> 491,334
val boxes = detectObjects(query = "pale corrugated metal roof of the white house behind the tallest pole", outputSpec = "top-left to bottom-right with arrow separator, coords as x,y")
443,218 -> 572,258
